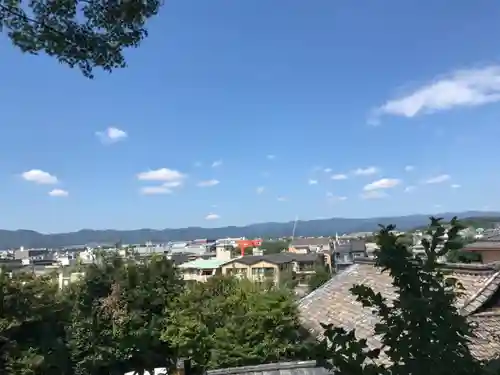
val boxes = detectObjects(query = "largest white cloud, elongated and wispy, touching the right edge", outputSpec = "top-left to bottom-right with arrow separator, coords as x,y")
372,65 -> 500,122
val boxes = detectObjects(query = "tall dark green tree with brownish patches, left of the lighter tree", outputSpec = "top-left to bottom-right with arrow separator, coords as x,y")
67,254 -> 182,375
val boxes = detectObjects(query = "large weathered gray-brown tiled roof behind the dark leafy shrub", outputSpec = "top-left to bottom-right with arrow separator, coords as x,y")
299,260 -> 500,359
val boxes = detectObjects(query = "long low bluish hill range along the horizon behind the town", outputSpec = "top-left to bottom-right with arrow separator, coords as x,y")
0,211 -> 500,249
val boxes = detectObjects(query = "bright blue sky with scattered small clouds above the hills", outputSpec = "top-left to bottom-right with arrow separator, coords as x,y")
0,0 -> 500,232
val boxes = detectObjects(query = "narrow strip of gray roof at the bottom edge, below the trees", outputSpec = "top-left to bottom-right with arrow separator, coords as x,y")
207,361 -> 330,375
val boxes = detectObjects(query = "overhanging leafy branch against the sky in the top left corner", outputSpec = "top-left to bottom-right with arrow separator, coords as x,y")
0,0 -> 161,77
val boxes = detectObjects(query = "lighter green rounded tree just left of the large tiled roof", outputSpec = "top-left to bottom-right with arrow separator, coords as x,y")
163,277 -> 312,368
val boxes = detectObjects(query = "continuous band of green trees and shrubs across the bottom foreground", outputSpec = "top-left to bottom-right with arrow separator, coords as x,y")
0,219 -> 496,375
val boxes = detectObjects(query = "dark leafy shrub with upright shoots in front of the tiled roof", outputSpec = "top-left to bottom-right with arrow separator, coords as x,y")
318,218 -> 482,375
